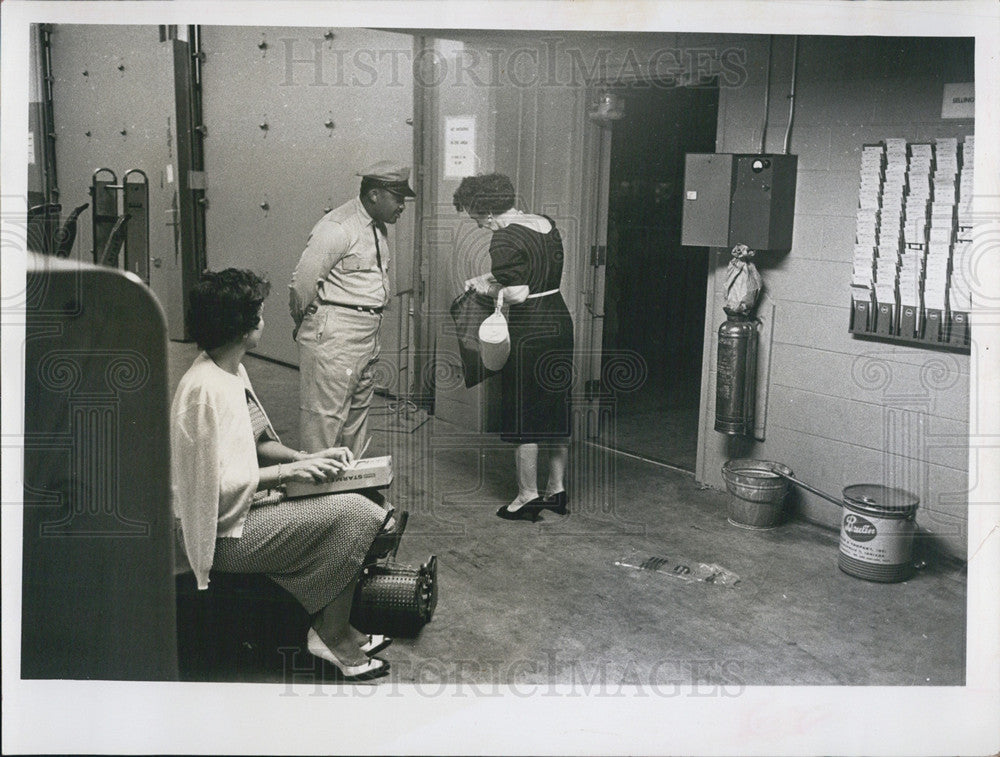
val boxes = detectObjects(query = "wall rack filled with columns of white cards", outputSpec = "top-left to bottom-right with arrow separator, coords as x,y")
849,135 -> 975,352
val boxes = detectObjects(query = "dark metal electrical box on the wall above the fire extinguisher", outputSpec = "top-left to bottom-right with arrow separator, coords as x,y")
681,153 -> 798,250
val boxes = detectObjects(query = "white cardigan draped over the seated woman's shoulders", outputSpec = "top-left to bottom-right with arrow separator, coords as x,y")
170,352 -> 277,589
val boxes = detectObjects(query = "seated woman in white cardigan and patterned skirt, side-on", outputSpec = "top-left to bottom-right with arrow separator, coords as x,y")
170,268 -> 390,679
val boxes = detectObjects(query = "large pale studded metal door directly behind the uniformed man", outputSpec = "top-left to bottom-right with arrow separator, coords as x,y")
200,26 -> 413,378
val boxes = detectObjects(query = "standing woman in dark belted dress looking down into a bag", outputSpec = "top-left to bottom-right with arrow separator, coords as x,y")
454,173 -> 573,520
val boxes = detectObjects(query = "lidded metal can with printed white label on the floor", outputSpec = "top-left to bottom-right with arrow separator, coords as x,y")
838,484 -> 920,583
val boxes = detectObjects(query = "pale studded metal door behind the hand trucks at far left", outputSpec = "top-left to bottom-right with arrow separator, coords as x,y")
50,24 -> 183,339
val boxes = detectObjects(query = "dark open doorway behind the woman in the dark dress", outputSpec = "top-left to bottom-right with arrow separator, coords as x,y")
601,83 -> 719,472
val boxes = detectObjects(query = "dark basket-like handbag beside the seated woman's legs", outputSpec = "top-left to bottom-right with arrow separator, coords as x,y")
351,552 -> 437,636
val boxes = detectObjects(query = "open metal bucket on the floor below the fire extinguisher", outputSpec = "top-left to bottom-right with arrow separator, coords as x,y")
722,458 -> 792,530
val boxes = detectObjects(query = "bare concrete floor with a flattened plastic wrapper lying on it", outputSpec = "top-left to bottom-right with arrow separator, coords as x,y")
170,343 -> 966,692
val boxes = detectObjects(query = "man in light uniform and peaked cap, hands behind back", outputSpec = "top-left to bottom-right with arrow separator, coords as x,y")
289,161 -> 416,456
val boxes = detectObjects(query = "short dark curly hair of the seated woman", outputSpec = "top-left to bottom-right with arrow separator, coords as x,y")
188,268 -> 271,350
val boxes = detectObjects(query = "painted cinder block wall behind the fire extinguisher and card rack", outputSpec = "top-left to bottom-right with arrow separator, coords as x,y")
697,37 -> 976,557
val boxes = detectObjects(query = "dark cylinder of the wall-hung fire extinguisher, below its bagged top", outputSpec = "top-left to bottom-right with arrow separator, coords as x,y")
715,312 -> 757,435
